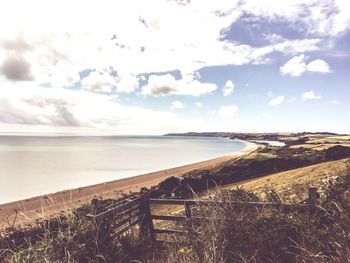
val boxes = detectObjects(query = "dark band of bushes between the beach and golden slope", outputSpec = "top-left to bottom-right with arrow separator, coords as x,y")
152,145 -> 350,198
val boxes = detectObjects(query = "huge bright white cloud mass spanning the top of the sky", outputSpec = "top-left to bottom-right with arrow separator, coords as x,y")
0,0 -> 340,89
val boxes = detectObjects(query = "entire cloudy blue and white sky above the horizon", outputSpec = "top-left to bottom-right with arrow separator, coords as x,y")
0,0 -> 350,135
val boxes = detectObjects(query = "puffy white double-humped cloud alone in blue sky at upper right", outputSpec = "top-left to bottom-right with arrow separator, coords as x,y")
280,54 -> 331,77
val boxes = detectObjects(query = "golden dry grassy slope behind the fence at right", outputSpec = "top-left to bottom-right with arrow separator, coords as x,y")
223,158 -> 350,201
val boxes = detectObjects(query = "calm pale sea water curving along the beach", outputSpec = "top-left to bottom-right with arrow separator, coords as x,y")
0,136 -> 245,204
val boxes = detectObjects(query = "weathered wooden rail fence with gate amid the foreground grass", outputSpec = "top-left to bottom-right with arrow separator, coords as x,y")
87,187 -> 318,241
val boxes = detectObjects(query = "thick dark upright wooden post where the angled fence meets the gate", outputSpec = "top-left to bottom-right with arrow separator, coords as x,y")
140,191 -> 155,242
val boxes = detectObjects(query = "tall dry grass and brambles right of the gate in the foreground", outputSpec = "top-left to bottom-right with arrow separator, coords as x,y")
159,168 -> 350,263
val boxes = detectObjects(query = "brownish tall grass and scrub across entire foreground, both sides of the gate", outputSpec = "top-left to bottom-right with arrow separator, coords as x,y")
0,166 -> 350,263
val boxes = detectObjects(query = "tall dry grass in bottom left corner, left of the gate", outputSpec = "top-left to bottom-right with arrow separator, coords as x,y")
0,201 -> 148,262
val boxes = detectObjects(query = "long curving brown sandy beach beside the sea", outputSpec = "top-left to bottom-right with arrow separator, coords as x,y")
0,142 -> 258,228
